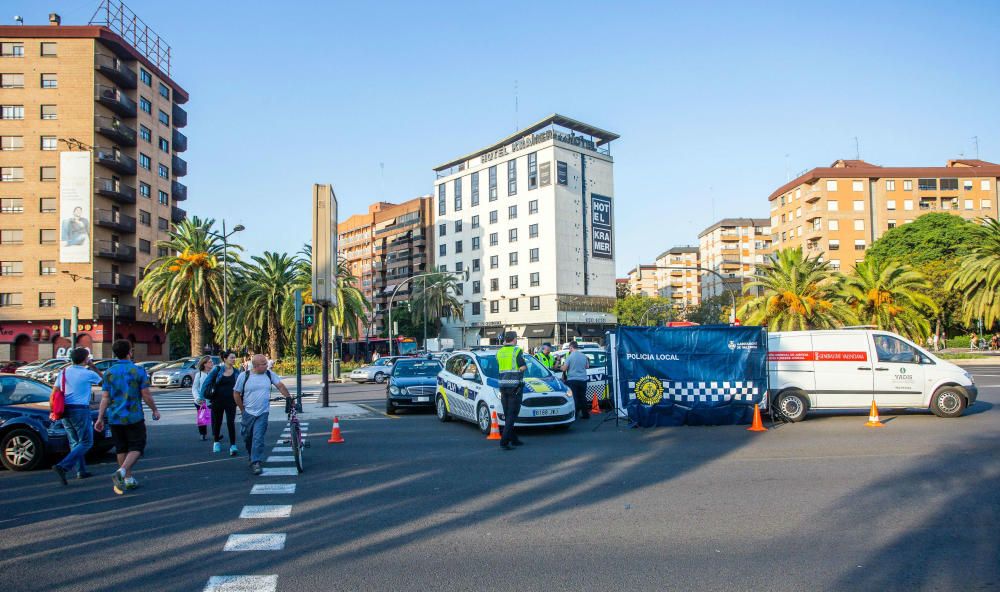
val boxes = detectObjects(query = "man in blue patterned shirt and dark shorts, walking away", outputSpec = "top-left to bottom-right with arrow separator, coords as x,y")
94,339 -> 160,495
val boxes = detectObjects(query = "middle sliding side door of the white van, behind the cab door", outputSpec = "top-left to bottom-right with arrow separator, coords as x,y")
813,330 -> 875,408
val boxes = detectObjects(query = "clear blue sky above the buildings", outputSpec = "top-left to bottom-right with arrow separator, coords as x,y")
9,0 -> 1000,275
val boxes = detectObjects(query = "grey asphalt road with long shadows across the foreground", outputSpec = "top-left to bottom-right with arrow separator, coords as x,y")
0,366 -> 1000,592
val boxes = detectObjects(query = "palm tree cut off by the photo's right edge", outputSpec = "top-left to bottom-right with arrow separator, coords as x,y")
945,218 -> 1000,330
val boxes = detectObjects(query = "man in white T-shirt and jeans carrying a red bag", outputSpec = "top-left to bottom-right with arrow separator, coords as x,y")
52,347 -> 101,485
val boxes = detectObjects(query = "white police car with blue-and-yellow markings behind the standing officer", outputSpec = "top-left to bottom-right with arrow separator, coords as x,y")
434,351 -> 576,434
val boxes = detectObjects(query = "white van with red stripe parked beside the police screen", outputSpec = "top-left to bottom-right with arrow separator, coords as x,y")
767,329 -> 978,421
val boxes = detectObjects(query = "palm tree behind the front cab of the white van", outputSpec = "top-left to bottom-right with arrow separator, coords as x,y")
841,258 -> 938,342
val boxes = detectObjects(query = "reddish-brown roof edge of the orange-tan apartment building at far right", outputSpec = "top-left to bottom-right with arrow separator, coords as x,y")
767,158 -> 1000,201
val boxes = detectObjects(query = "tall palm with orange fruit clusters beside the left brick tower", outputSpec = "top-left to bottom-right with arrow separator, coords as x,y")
135,216 -> 242,355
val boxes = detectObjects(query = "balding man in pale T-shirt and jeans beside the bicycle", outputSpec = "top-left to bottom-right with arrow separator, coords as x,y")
233,354 -> 292,475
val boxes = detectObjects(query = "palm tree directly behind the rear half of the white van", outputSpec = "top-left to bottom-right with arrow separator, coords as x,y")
739,247 -> 855,331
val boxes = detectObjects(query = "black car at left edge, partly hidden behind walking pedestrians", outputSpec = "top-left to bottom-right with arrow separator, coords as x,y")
0,374 -> 114,471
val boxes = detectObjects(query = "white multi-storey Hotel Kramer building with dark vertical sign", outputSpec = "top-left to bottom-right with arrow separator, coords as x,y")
432,115 -> 618,347
